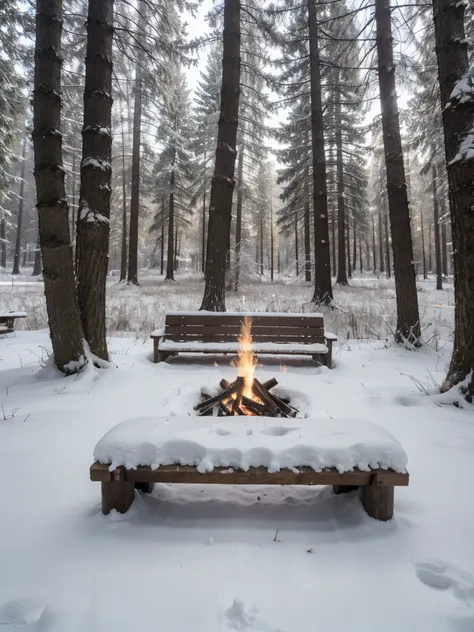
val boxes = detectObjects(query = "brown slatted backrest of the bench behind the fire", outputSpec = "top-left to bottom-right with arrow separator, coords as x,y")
165,312 -> 324,343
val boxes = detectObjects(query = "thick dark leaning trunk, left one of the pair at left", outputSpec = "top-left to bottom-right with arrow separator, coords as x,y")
33,0 -> 87,374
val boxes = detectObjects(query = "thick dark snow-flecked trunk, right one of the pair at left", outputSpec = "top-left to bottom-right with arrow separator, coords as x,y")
76,0 -> 114,360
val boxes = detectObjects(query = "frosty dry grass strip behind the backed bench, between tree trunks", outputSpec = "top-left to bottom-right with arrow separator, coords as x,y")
0,273 -> 454,347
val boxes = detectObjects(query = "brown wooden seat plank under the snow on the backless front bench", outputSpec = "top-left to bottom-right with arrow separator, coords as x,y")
90,462 -> 409,487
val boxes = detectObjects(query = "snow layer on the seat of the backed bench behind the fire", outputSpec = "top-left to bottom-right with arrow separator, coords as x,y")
157,340 -> 328,355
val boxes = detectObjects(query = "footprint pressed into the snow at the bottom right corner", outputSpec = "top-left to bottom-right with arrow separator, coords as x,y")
415,560 -> 474,606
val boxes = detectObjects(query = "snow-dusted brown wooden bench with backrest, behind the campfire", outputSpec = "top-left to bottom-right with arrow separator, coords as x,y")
151,311 -> 337,368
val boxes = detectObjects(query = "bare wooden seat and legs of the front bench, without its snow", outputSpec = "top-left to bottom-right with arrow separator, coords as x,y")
90,461 -> 409,520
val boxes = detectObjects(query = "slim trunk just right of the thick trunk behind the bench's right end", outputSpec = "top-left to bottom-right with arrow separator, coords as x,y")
334,87 -> 348,285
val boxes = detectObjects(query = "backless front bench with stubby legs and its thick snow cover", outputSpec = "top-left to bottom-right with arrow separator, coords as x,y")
90,417 -> 408,520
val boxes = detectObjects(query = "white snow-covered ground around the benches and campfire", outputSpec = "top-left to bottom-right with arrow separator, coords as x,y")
0,320 -> 474,632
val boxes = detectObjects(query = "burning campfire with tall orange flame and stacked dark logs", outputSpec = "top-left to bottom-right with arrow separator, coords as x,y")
194,318 -> 298,417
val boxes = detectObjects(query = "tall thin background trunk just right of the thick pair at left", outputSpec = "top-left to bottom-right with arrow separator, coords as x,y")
127,31 -> 145,285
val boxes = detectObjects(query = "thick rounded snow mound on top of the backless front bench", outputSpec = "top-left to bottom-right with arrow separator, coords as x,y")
94,417 -> 407,472
